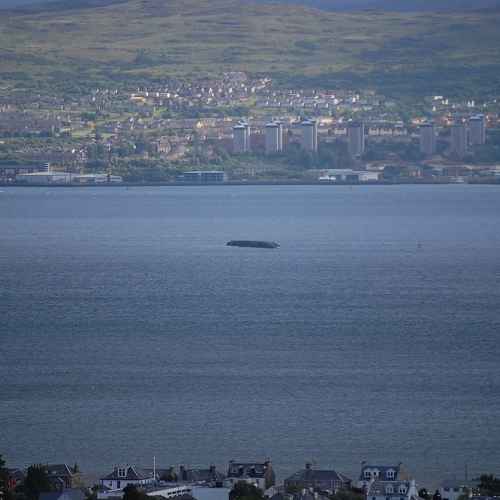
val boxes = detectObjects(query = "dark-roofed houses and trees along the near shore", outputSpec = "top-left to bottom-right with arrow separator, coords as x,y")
0,456 -> 500,500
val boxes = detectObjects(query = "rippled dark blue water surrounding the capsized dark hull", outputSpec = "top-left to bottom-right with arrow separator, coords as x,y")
0,185 -> 500,483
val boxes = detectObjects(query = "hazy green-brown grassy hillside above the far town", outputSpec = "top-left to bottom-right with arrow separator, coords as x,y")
0,0 -> 500,93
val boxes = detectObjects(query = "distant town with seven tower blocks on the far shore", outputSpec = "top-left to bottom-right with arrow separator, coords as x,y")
0,72 -> 500,185
